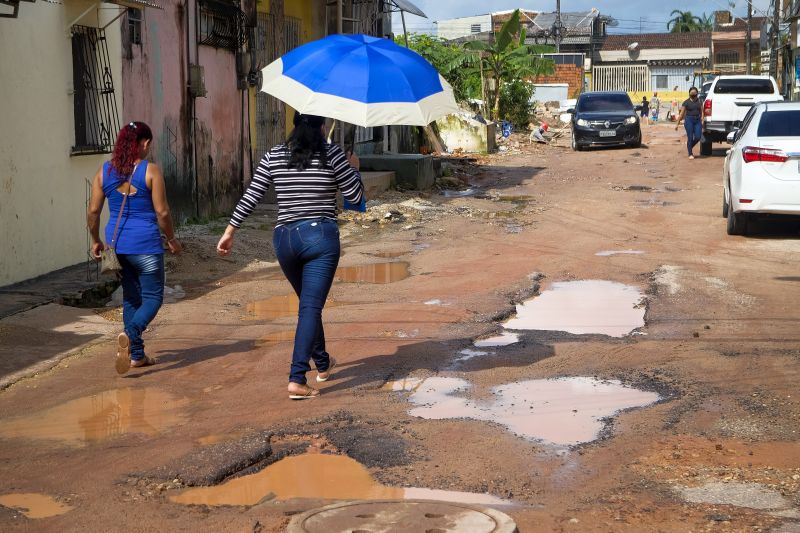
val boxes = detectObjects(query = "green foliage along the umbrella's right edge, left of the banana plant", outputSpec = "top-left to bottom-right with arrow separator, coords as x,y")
395,33 -> 481,102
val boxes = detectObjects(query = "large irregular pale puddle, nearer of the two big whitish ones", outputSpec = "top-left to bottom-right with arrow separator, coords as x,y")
409,377 -> 659,446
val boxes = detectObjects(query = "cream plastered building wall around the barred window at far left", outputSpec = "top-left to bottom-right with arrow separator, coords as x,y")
0,0 -> 122,286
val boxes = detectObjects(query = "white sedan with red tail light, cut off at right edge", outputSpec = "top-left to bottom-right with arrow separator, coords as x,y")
722,102 -> 800,235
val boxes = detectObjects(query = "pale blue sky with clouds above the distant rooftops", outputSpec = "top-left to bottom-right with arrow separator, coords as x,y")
392,0 -> 770,34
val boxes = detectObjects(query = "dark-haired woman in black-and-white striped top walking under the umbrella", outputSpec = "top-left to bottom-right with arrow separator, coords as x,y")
212,113 -> 364,400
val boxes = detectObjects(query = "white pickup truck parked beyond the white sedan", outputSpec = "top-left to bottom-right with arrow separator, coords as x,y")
700,75 -> 783,155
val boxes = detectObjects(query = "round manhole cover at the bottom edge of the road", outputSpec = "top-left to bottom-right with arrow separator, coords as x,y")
286,500 -> 517,533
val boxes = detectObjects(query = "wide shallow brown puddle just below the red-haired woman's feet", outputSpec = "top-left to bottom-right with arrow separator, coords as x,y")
0,388 -> 186,446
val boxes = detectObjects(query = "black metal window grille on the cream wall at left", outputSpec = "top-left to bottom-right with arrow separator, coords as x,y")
72,26 -> 120,155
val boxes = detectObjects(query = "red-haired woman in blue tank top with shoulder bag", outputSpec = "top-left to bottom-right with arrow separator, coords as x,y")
87,122 -> 182,374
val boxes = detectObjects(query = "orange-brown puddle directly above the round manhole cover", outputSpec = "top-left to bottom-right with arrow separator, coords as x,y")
170,454 -> 509,506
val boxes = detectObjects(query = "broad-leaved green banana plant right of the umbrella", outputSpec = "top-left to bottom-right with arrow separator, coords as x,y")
464,10 -> 553,120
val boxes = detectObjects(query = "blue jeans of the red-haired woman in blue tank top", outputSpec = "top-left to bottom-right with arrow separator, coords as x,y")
117,254 -> 164,361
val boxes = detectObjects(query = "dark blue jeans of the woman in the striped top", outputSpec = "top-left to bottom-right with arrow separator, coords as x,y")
272,218 -> 340,385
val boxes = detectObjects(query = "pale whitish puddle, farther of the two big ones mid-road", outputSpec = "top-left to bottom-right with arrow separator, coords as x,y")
504,280 -> 645,336
